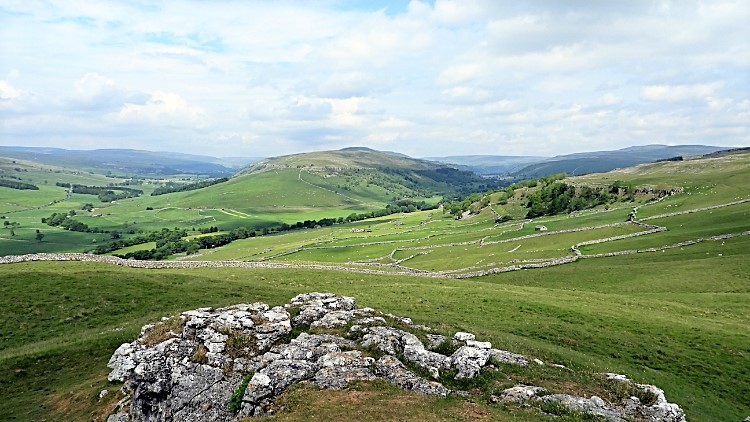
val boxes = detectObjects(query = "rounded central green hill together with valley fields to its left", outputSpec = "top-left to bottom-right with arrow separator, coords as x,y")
0,148 -> 502,255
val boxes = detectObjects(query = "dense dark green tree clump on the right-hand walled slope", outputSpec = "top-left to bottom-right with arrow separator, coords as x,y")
526,182 -> 611,218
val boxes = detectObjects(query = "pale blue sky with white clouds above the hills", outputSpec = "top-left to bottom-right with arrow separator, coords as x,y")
0,0 -> 750,157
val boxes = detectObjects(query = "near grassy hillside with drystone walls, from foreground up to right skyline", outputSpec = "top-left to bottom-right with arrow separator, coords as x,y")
0,152 -> 750,421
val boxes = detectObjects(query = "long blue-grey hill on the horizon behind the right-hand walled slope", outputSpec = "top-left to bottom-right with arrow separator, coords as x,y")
510,145 -> 731,179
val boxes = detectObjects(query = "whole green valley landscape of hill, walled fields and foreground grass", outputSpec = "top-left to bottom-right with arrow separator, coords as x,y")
0,149 -> 750,420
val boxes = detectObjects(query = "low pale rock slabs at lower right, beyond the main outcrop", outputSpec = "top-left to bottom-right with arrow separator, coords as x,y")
493,374 -> 686,422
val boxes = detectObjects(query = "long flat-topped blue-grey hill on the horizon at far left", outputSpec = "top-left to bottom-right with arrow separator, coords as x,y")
0,146 -> 256,177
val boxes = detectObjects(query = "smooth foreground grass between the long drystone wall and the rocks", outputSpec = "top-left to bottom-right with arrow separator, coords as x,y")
0,238 -> 750,420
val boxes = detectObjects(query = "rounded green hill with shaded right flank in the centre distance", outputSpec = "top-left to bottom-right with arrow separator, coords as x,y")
101,148 -> 506,229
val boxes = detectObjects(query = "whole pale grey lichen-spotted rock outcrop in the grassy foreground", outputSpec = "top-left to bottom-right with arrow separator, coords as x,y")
108,293 -> 685,422
